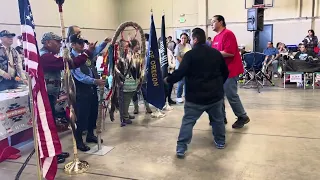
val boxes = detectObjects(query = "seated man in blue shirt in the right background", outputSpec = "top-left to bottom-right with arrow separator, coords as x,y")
263,41 -> 280,78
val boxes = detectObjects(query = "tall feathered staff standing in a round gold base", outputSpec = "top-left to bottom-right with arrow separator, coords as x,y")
55,0 -> 89,174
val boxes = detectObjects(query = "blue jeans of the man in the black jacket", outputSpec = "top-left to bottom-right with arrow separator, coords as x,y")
177,99 -> 226,151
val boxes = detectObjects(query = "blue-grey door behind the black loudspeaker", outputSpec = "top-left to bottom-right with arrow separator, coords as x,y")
256,24 -> 275,52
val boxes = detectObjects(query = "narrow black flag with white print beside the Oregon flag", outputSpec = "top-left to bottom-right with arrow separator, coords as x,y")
160,15 -> 168,78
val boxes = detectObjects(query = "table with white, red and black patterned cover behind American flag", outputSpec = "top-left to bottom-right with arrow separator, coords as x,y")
0,88 -> 32,141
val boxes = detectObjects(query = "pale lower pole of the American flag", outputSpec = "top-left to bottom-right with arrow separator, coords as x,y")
28,75 -> 42,180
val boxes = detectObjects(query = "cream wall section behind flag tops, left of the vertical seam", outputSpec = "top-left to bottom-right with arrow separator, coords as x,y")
120,0 -> 202,39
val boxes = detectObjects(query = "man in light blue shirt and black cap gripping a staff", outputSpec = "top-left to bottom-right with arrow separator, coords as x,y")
69,34 -> 111,151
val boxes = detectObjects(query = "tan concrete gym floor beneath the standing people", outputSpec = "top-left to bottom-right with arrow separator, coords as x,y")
0,87 -> 320,180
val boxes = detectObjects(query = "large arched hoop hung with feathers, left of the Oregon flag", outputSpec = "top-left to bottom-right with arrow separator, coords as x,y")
108,22 -> 145,126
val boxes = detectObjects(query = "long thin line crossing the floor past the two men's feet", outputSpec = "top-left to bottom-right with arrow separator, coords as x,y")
107,123 -> 320,140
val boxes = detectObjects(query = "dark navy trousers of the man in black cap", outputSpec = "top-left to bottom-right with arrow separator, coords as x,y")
76,93 -> 99,141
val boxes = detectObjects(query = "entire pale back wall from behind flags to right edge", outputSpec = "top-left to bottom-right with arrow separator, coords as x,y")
120,0 -> 320,48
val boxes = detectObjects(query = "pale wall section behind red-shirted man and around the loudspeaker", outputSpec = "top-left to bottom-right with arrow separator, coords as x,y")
209,0 -> 320,48
